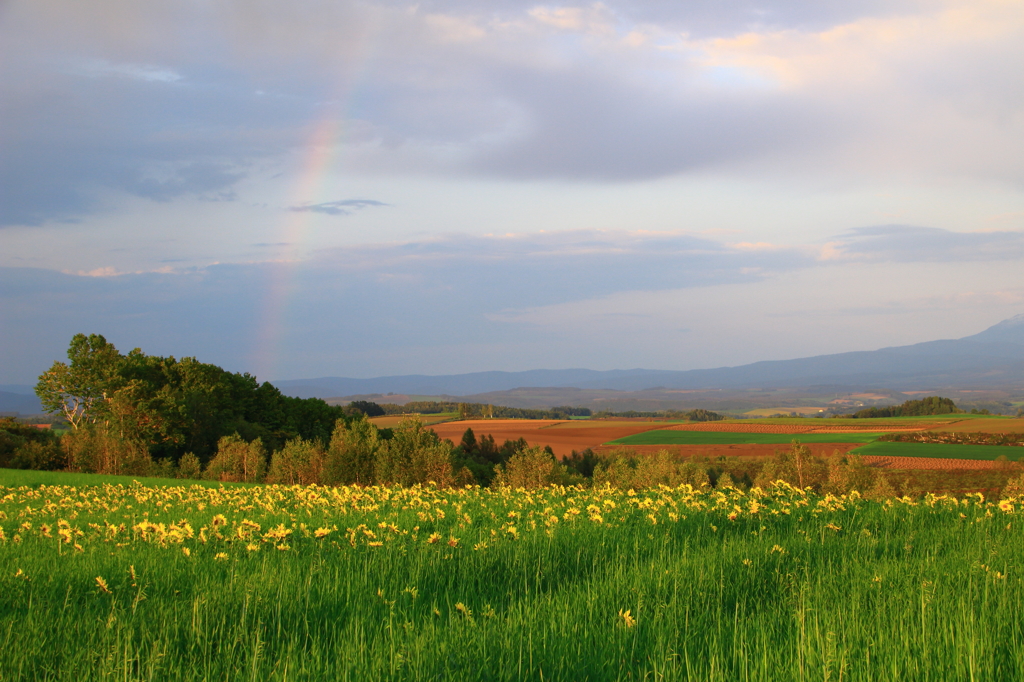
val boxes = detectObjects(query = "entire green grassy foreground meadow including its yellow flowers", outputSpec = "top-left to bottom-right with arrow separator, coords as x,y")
0,479 -> 1024,680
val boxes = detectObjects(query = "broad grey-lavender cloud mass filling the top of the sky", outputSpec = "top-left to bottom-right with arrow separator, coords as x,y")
0,0 -> 1024,225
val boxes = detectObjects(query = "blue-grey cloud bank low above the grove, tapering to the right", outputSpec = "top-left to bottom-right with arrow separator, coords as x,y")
0,231 -> 815,380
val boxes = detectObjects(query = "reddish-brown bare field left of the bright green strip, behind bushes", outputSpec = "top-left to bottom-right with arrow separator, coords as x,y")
423,419 -> 665,457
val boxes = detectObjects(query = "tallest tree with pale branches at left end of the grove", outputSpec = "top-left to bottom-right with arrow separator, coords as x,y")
36,334 -> 124,429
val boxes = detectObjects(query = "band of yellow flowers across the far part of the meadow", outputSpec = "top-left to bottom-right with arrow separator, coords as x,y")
0,482 -> 1021,561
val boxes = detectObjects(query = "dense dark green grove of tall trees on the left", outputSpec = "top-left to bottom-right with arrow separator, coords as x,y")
36,334 -> 345,464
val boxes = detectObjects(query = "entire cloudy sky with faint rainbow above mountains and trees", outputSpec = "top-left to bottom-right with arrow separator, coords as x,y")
0,0 -> 1024,384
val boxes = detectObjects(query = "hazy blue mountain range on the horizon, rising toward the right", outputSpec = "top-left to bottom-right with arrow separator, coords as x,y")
273,314 -> 1024,398
